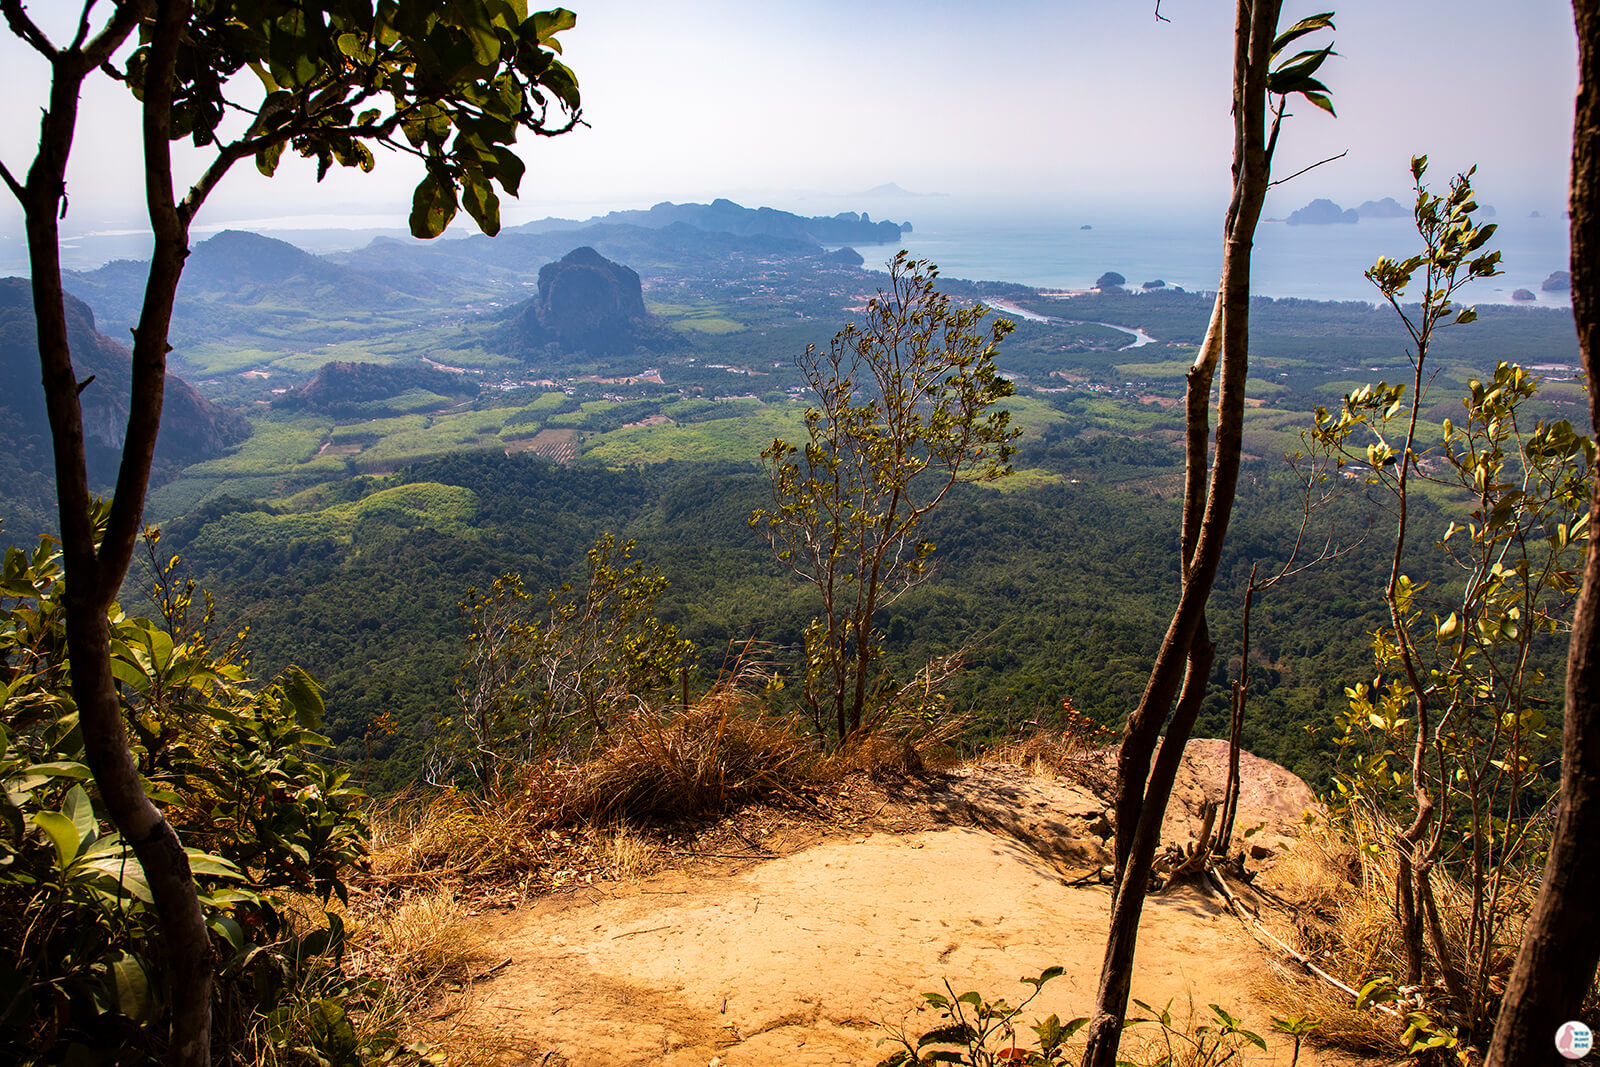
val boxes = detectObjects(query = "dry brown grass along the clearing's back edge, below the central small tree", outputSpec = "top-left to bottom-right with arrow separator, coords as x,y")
371,648 -> 966,902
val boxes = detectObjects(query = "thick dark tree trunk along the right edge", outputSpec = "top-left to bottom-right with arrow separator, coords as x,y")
1488,0 -> 1600,1067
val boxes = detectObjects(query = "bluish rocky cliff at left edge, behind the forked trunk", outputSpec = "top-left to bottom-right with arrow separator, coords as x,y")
0,278 -> 250,488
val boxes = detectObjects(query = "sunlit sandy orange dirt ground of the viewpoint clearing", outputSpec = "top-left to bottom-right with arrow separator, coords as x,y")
434,742 -> 1376,1067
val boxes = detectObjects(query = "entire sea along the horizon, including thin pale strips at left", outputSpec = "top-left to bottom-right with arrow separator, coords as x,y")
0,197 -> 1570,307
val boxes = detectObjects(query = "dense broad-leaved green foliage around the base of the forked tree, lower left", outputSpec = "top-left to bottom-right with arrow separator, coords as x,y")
0,531 -> 411,1064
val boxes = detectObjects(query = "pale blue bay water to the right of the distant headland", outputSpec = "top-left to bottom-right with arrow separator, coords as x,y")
858,202 -> 1568,307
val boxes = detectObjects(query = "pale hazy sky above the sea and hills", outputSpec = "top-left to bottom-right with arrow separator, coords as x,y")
0,0 -> 1576,235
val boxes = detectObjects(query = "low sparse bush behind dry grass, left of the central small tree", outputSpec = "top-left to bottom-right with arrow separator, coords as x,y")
438,534 -> 694,789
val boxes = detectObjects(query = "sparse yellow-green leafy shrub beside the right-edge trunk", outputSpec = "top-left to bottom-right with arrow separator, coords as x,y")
1315,157 -> 1595,1037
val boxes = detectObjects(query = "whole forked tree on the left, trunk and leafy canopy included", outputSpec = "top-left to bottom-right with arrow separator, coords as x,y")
0,0 -> 579,1067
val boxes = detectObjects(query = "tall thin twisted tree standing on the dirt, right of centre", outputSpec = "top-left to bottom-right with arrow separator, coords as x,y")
1083,0 -> 1333,1067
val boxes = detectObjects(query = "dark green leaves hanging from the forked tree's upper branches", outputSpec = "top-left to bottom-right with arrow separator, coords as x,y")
128,0 -> 579,237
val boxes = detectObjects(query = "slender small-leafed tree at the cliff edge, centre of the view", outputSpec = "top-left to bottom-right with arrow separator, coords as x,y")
750,251 -> 1021,745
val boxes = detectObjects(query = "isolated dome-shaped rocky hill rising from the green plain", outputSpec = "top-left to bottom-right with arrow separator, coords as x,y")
502,246 -> 662,357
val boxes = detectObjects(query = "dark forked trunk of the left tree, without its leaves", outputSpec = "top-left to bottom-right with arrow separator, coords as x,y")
21,0 -> 211,1067
